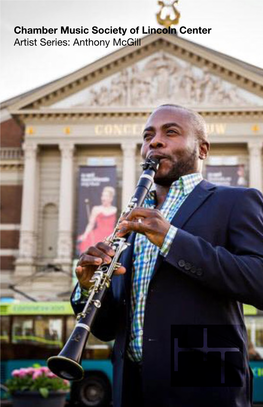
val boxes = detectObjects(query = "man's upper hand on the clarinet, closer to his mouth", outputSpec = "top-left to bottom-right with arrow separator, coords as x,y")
117,208 -> 170,248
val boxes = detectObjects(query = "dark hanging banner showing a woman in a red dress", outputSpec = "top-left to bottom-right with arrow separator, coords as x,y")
76,166 -> 117,256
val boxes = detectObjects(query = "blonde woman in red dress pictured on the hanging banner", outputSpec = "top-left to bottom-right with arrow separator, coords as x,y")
78,186 -> 117,253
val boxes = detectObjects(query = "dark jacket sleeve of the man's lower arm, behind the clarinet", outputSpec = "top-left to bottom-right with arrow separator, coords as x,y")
70,286 -> 118,342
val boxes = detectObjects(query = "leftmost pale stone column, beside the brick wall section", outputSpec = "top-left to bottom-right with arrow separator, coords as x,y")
16,143 -> 38,265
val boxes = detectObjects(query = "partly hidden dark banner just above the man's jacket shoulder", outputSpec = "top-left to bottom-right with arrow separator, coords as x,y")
206,165 -> 248,187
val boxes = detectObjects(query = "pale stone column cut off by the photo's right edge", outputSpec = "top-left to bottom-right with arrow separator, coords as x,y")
248,140 -> 263,191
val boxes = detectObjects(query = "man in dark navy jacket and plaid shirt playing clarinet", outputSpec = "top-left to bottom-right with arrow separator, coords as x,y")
72,105 -> 263,407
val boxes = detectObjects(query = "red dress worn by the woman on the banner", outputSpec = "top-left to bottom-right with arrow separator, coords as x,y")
78,213 -> 116,253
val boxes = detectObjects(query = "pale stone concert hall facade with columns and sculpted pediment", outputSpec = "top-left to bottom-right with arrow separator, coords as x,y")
0,35 -> 263,299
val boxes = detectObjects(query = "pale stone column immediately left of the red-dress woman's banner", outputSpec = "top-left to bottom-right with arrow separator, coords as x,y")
55,142 -> 74,271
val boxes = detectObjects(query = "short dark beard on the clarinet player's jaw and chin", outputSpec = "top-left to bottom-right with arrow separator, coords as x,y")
154,149 -> 198,186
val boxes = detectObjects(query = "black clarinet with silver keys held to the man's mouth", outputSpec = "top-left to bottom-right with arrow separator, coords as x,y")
47,158 -> 159,380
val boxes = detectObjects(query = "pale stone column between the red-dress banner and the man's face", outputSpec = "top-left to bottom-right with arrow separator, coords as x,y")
121,142 -> 136,208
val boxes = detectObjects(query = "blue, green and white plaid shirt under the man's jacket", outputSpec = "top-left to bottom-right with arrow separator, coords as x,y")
73,173 -> 203,362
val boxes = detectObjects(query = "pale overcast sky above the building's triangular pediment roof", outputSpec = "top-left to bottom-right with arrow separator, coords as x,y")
0,0 -> 263,101
